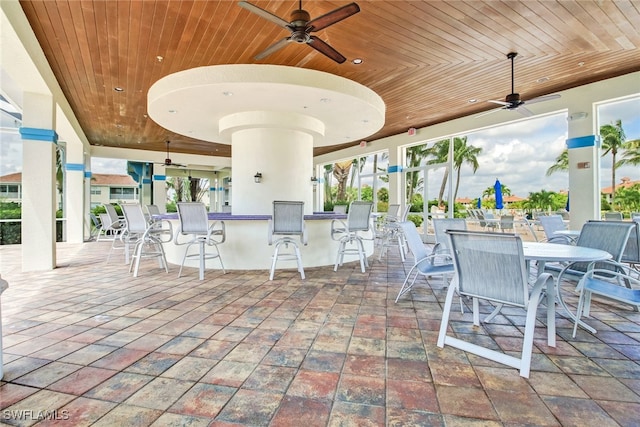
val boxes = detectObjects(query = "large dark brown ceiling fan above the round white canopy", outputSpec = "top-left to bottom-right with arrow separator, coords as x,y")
238,0 -> 360,64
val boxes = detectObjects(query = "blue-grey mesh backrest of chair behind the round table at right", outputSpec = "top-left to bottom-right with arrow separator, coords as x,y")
571,220 -> 634,271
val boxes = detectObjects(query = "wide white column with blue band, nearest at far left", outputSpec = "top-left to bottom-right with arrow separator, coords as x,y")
20,92 -> 58,271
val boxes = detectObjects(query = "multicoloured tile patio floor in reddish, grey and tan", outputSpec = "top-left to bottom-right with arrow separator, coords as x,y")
0,242 -> 640,427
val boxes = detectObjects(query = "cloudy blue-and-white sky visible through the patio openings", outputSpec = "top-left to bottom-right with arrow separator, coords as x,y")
0,97 -> 640,199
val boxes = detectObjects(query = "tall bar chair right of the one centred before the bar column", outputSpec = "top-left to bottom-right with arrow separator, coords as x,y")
331,201 -> 373,273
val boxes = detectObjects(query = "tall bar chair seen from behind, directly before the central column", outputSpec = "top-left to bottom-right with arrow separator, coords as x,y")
268,201 -> 307,280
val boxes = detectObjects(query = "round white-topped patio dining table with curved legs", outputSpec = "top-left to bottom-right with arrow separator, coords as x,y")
522,242 -> 612,346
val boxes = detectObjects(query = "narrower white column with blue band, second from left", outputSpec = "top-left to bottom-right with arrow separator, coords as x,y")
64,140 -> 88,243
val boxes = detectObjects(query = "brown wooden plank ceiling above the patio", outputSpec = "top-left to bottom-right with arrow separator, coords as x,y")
20,0 -> 640,156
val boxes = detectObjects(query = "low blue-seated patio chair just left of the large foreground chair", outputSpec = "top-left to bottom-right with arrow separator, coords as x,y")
396,221 -> 454,302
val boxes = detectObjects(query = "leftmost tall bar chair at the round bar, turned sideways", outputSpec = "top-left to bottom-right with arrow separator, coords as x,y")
121,203 -> 173,277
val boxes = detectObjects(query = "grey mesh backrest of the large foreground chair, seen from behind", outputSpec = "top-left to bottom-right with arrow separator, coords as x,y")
447,230 -> 529,307
